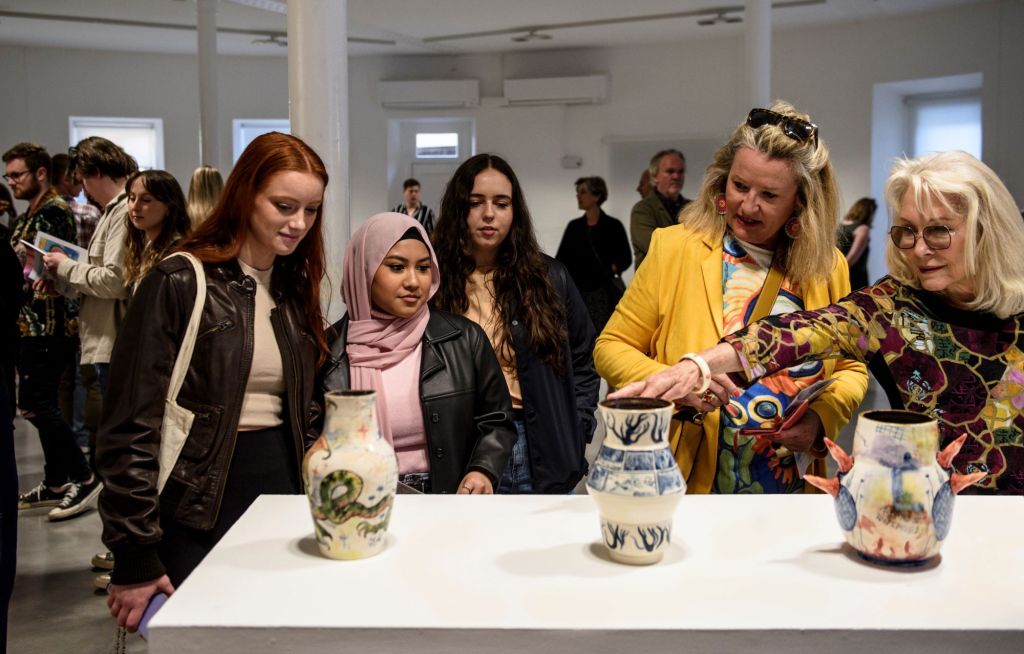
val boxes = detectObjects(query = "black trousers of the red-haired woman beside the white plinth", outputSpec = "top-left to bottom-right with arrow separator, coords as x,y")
160,427 -> 303,587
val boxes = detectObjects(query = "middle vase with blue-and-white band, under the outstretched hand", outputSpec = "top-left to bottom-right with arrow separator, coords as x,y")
587,397 -> 686,565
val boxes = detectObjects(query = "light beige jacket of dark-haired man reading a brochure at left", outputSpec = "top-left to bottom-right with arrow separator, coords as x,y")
57,193 -> 128,363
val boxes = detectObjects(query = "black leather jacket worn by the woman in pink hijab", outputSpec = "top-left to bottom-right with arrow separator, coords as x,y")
318,309 -> 516,493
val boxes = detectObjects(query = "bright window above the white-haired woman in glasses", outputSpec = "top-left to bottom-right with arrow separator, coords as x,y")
906,93 -> 981,159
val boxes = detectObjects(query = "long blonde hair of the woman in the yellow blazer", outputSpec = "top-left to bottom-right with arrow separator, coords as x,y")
679,100 -> 839,282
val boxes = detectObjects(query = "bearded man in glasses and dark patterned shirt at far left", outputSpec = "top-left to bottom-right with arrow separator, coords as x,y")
3,143 -> 100,520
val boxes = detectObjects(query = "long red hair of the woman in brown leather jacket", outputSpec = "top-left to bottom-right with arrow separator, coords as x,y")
178,132 -> 328,362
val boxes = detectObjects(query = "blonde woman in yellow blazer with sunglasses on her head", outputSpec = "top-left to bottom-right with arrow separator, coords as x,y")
594,102 -> 867,493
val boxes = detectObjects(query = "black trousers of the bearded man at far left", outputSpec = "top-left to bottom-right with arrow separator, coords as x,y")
17,336 -> 90,486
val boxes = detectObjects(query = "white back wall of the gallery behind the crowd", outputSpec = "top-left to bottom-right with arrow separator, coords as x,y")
0,0 -> 1024,272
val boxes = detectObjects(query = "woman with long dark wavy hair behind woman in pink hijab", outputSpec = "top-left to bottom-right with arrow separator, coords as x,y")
432,155 -> 600,493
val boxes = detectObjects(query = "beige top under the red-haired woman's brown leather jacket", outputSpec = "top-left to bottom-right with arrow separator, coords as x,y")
239,259 -> 285,432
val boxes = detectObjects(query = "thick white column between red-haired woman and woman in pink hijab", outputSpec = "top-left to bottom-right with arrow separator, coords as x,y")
288,0 -> 351,320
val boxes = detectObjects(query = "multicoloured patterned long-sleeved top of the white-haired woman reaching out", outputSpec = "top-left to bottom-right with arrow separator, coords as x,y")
724,277 -> 1024,494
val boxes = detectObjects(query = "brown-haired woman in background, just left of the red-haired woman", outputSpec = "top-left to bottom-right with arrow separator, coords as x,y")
125,170 -> 191,290
